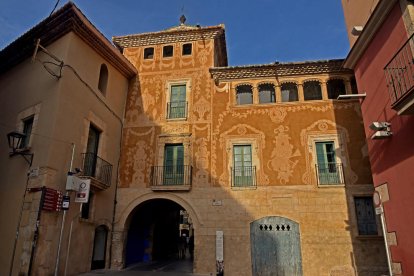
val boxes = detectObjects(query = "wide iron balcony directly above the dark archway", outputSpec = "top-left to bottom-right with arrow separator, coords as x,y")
150,165 -> 193,191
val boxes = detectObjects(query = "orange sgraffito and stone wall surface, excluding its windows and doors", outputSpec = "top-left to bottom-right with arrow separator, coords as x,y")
112,31 -> 386,275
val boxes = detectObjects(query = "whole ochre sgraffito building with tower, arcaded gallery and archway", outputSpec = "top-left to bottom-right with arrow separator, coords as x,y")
111,23 -> 386,275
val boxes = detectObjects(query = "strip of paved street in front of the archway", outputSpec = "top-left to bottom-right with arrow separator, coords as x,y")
81,259 -> 210,276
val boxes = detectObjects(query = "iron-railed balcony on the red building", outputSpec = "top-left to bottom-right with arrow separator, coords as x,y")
384,33 -> 414,115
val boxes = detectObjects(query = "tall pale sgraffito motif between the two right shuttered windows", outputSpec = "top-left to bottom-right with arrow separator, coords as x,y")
267,126 -> 300,184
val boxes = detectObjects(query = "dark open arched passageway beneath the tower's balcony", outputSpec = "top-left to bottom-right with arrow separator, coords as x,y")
125,198 -> 194,267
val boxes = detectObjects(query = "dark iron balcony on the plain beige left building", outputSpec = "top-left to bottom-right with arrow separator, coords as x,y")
82,152 -> 112,190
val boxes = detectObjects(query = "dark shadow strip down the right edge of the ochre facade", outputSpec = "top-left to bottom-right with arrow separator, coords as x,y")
332,100 -> 388,275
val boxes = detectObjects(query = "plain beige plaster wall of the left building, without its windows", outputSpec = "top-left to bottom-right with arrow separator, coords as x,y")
0,29 -> 128,275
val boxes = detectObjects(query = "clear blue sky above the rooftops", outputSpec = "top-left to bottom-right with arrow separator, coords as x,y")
0,0 -> 349,65
